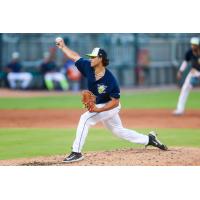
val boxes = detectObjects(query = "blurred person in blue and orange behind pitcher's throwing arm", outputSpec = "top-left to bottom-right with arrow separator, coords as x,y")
64,59 -> 81,92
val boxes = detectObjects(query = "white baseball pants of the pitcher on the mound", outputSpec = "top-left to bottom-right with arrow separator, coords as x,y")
73,104 -> 149,152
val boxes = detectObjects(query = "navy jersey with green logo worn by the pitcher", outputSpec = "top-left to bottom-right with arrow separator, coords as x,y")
75,58 -> 120,104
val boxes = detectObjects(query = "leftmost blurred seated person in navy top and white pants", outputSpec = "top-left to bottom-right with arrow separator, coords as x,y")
5,52 -> 33,89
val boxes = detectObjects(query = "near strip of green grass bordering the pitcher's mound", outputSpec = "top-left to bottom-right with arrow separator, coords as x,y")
0,128 -> 200,160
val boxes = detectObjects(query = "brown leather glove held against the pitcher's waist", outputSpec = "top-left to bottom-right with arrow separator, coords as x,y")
82,90 -> 96,111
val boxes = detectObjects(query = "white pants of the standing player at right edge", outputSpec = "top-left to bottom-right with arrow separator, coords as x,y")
177,69 -> 200,112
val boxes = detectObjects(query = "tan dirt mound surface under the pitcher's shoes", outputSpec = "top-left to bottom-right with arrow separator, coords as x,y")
0,148 -> 200,166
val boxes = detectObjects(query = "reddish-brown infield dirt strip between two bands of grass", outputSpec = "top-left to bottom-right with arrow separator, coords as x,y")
0,109 -> 200,128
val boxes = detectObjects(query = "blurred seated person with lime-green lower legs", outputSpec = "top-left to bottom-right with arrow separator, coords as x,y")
40,52 -> 69,91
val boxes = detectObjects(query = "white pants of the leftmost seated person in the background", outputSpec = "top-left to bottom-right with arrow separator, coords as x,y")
8,72 -> 33,89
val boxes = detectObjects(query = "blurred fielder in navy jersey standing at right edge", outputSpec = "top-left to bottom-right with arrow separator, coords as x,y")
173,37 -> 200,115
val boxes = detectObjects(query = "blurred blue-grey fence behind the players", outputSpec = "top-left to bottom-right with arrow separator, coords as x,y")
1,33 -> 199,87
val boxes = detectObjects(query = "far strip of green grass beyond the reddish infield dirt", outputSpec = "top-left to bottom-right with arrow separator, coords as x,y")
0,90 -> 200,109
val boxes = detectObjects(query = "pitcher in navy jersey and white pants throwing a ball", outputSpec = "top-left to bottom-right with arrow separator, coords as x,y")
56,38 -> 167,163
